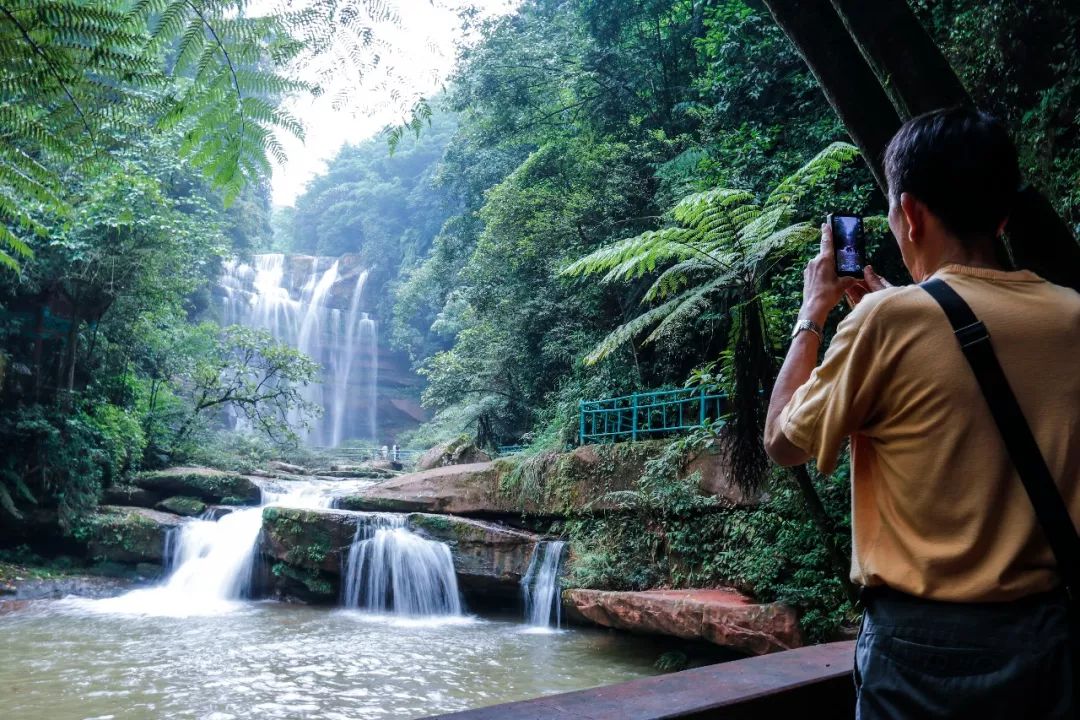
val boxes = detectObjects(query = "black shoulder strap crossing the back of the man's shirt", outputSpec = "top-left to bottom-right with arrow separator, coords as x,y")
921,279 -> 1080,593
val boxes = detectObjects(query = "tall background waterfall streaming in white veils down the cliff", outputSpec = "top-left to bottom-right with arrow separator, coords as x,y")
218,253 -> 378,447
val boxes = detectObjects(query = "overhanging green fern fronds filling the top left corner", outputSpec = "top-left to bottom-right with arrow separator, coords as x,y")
0,0 -> 307,270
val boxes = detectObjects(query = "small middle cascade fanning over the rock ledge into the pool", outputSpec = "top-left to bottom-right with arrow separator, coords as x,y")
341,515 -> 461,616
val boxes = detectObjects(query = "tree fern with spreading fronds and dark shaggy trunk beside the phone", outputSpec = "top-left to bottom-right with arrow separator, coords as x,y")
564,142 -> 858,491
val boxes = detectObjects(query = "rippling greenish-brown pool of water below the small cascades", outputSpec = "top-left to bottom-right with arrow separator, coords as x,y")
0,599 -> 658,720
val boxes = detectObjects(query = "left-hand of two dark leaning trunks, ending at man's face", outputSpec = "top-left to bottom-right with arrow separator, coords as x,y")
765,0 -> 901,192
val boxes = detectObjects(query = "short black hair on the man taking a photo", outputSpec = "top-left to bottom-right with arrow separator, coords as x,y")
885,107 -> 1021,243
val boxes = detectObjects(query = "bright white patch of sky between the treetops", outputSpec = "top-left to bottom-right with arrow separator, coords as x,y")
271,0 -> 516,206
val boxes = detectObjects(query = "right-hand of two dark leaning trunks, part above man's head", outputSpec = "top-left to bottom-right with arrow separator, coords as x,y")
832,0 -> 971,120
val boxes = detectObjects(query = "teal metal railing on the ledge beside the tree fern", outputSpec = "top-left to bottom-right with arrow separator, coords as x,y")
578,386 -> 728,445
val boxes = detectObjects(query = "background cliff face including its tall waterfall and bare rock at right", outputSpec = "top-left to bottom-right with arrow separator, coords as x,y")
216,254 -> 426,446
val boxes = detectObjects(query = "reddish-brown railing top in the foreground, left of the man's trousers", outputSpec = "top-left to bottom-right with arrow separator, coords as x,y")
419,642 -> 855,720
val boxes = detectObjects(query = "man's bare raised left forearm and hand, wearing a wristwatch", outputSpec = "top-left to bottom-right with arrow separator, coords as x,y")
765,222 -> 859,466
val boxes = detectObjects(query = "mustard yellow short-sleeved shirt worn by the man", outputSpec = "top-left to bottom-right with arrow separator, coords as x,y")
781,264 -> 1080,601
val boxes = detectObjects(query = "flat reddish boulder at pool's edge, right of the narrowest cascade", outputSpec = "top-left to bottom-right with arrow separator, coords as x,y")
563,589 -> 802,655
